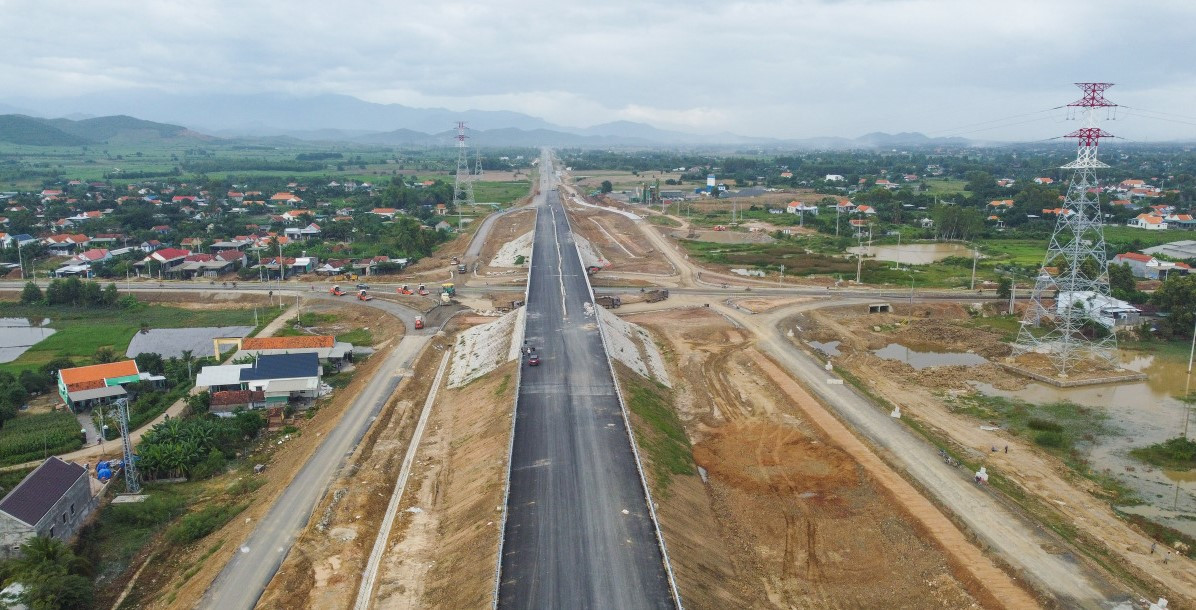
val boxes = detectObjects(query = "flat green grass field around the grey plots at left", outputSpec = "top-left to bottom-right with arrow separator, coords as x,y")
0,303 -> 277,374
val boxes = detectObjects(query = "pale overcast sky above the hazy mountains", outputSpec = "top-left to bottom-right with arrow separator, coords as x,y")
0,0 -> 1196,141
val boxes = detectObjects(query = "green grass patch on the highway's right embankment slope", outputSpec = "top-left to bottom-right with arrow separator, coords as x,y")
621,372 -> 695,494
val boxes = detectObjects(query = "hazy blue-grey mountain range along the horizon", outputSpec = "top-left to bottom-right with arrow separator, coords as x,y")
0,92 -> 976,150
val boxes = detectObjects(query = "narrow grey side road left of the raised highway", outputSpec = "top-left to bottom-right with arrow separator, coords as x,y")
200,297 -> 437,610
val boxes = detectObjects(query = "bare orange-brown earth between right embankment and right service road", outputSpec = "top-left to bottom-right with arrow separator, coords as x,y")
628,309 -> 990,609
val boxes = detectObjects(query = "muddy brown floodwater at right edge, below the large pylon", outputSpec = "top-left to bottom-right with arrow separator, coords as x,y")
974,350 -> 1196,536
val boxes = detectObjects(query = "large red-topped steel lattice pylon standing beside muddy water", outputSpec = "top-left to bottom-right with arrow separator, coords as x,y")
1013,83 -> 1117,377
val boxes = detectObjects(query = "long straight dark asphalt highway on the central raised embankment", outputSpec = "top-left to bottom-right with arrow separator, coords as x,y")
498,157 -> 675,609
